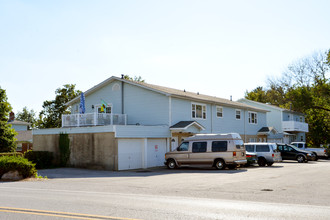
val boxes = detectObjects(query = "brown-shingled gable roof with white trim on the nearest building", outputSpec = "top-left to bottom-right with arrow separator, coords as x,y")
66,76 -> 268,112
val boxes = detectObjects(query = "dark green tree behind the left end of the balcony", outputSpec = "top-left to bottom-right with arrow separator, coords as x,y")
37,84 -> 81,128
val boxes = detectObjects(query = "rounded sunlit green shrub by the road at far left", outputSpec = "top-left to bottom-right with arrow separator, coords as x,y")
0,156 -> 37,178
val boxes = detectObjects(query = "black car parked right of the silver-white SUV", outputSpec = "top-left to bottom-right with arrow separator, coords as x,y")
277,144 -> 316,163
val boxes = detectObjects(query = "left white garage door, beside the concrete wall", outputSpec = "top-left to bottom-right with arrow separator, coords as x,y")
118,139 -> 144,170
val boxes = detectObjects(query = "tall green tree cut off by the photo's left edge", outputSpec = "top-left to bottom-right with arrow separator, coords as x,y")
0,87 -> 17,152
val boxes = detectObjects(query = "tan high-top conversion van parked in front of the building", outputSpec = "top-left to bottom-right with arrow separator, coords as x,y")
165,133 -> 247,170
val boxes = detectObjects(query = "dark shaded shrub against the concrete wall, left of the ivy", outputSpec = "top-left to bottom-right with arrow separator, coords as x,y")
24,150 -> 54,169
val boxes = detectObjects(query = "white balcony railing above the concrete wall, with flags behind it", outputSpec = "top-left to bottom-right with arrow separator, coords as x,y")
62,113 -> 127,127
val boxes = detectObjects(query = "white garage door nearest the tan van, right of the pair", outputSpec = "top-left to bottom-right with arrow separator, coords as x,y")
147,139 -> 166,167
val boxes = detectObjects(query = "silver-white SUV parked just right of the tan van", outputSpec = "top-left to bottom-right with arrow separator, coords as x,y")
244,143 -> 282,167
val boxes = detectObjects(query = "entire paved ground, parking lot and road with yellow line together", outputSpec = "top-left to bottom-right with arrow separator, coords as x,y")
0,160 -> 330,219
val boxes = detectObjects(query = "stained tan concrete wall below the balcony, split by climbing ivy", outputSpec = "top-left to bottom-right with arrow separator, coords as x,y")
33,132 -> 118,170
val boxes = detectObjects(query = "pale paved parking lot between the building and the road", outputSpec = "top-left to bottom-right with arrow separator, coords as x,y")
39,160 -> 330,205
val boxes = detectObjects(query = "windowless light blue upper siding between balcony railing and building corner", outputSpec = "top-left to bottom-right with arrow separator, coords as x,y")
124,83 -> 169,126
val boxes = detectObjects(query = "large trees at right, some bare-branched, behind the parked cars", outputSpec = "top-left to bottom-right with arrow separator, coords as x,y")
245,50 -> 330,146
